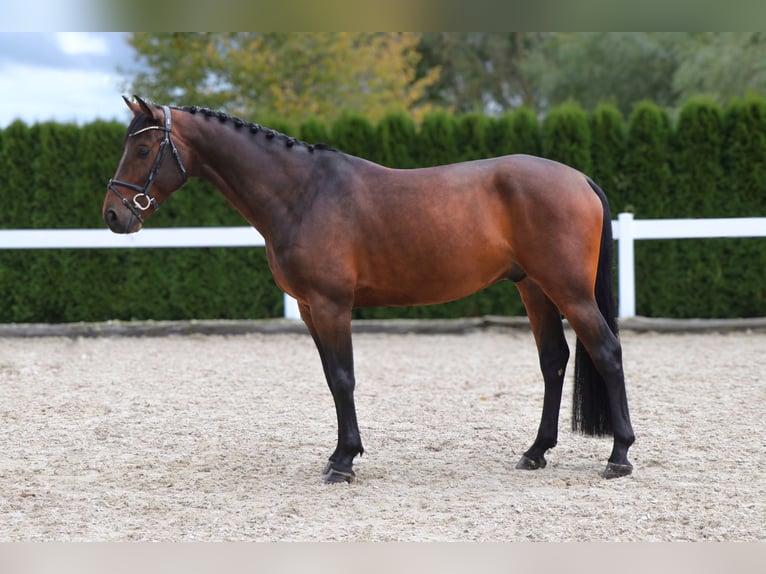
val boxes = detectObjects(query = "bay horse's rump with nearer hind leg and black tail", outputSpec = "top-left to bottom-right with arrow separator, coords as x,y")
498,160 -> 634,476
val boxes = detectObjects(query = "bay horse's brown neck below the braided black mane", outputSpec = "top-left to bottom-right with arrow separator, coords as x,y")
191,117 -> 311,241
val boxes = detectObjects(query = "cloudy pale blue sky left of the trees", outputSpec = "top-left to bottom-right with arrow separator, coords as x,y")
0,32 -> 136,128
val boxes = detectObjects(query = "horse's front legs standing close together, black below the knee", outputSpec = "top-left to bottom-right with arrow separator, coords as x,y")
300,301 -> 364,483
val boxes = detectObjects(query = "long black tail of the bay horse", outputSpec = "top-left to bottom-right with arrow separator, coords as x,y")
572,178 -> 618,436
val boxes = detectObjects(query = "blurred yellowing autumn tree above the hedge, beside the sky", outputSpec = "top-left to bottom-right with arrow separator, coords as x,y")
123,32 -> 439,125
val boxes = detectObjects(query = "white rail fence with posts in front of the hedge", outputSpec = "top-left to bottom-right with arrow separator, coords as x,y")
0,213 -> 766,319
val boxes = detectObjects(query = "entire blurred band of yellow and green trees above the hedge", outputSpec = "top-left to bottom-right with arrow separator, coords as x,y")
121,32 -> 766,124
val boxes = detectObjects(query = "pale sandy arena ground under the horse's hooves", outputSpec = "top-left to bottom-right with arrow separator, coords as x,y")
0,329 -> 766,541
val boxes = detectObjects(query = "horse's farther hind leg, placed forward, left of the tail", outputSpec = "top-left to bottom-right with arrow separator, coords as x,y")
516,277 -> 569,470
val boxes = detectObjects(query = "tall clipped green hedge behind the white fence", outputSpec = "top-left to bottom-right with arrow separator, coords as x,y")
0,100 -> 766,322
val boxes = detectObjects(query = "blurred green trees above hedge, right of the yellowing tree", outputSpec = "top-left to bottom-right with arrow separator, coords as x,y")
418,32 -> 766,116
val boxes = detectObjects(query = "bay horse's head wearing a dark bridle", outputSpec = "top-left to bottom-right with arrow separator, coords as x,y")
103,96 -> 186,233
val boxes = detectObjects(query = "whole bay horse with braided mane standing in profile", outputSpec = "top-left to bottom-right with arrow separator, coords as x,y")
103,96 -> 635,483
